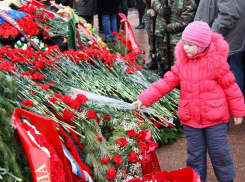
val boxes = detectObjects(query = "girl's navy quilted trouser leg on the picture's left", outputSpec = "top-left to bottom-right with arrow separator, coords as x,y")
183,125 -> 207,181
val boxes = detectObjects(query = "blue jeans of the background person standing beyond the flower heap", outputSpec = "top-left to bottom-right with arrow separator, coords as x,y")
102,14 -> 117,41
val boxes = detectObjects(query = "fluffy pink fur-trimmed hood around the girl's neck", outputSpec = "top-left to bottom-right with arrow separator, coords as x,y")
174,32 -> 229,69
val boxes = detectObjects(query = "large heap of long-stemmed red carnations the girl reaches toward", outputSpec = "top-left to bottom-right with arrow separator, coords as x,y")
0,1 -> 179,181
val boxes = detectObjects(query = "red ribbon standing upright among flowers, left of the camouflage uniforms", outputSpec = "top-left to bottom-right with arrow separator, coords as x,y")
118,13 -> 140,54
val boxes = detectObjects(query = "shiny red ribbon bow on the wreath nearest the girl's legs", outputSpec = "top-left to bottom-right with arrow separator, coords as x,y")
137,130 -> 161,175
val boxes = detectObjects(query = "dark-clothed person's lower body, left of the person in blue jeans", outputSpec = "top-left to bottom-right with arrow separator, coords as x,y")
73,0 -> 97,26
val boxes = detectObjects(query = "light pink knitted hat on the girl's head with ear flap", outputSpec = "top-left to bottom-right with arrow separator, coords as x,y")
182,20 -> 211,54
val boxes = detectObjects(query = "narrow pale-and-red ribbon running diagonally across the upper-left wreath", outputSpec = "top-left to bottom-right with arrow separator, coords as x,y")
0,9 -> 41,51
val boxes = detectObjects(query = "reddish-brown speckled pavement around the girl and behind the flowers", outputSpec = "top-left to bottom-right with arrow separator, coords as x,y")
95,9 -> 245,182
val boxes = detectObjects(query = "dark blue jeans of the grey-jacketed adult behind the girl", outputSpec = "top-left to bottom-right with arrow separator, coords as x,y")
229,52 -> 243,91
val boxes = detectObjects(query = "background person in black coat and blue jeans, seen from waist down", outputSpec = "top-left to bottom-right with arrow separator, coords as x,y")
97,0 -> 120,42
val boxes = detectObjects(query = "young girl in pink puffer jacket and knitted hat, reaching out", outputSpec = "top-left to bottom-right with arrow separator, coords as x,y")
133,21 -> 245,182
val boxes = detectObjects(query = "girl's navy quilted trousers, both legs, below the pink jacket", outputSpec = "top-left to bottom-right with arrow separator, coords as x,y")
183,123 -> 236,182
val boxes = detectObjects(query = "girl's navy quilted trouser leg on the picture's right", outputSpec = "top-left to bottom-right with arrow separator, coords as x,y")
205,123 -> 236,182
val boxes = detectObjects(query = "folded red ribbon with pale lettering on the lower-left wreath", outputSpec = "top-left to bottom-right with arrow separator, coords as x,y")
11,108 -> 73,182
